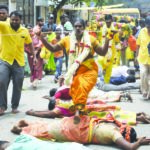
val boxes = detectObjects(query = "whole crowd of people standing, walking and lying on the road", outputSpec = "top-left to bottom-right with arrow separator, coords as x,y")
0,5 -> 150,150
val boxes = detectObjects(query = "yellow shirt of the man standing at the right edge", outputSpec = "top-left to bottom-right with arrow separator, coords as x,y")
137,28 -> 150,64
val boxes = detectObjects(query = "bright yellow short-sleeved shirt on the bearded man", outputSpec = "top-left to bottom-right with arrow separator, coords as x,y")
0,21 -> 32,66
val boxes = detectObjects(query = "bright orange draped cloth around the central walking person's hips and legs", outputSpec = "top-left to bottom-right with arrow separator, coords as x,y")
69,60 -> 98,105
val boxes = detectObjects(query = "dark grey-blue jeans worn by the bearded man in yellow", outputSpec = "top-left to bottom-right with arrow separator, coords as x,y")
0,60 -> 24,110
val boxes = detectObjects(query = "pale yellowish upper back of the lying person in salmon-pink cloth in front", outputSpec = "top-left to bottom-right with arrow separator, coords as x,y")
92,123 -> 122,144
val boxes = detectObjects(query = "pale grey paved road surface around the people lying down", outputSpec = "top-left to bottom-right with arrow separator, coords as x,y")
0,76 -> 150,150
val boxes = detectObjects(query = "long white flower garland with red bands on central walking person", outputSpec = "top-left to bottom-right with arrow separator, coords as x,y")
64,31 -> 91,85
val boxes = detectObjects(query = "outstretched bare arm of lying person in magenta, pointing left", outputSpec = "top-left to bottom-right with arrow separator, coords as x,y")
26,110 -> 60,118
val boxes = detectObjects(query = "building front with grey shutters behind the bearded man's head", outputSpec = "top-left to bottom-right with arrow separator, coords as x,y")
8,0 -> 49,25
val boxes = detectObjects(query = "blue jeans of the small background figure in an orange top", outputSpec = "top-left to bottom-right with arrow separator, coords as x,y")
54,57 -> 63,79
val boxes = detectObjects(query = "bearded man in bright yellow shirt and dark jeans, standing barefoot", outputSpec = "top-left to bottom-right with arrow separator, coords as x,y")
0,11 -> 36,115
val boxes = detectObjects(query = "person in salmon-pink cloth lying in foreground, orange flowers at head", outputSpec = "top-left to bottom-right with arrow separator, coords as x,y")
11,116 -> 150,150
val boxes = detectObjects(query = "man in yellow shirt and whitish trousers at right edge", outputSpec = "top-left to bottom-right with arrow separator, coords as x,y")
137,16 -> 150,99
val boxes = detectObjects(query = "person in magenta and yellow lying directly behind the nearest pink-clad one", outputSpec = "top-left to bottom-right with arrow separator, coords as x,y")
26,96 -> 150,125
